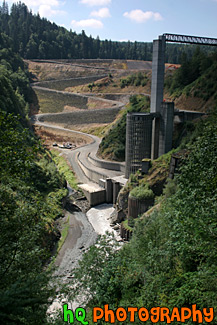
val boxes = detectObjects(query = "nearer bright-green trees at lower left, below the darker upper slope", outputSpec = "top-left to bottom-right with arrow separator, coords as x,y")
0,112 -> 60,324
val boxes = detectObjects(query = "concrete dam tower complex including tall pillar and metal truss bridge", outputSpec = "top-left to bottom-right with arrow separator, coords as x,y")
125,34 -> 217,178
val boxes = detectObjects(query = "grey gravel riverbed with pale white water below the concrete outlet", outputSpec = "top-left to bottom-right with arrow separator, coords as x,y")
48,200 -> 121,314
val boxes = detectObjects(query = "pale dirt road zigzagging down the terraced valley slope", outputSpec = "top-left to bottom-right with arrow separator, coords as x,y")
31,71 -> 124,187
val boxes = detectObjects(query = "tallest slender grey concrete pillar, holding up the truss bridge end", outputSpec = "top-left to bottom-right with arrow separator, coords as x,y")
151,36 -> 166,159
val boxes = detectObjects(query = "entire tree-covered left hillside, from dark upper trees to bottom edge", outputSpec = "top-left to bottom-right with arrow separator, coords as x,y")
0,34 -> 67,325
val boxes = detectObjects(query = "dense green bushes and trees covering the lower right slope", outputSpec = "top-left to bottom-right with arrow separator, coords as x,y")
69,107 -> 217,324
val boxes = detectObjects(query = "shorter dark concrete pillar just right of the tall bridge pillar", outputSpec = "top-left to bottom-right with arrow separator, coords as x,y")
159,102 -> 174,156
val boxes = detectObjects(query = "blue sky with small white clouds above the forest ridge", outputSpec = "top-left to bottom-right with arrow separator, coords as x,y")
6,0 -> 217,42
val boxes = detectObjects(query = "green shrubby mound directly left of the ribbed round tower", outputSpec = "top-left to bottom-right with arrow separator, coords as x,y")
99,95 -> 149,161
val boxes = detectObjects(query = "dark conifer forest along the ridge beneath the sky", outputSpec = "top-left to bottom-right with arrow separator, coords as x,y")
0,1 -> 214,63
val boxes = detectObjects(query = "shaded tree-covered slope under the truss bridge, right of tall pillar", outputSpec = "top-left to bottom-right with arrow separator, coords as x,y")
165,47 -> 217,109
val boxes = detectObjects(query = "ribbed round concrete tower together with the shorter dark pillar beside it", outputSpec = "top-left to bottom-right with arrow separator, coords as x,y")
125,102 -> 174,178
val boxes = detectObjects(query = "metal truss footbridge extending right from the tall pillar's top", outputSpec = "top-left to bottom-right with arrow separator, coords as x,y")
163,33 -> 217,46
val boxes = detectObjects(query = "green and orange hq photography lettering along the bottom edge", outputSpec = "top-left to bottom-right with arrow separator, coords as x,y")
63,304 -> 214,325
